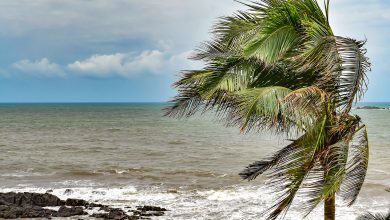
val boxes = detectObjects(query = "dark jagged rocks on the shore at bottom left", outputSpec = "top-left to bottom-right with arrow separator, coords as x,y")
0,192 -> 168,220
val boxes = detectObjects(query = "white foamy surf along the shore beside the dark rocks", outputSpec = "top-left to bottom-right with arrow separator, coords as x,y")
0,186 -> 390,220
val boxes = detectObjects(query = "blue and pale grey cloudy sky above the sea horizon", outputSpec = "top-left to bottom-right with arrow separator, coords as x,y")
0,0 -> 390,102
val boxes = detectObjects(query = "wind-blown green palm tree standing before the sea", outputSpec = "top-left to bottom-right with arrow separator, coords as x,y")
167,0 -> 370,219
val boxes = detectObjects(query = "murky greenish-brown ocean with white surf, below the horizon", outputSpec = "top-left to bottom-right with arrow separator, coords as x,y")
0,103 -> 390,220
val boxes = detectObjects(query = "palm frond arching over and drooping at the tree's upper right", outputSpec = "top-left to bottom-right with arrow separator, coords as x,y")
293,34 -> 370,112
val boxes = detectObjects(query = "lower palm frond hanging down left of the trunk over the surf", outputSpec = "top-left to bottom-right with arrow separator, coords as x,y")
241,111 -> 328,219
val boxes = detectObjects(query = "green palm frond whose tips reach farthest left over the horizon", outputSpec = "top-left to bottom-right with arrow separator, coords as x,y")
166,58 -> 261,118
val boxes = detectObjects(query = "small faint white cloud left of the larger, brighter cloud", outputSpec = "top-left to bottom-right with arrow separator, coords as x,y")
12,58 -> 66,77
